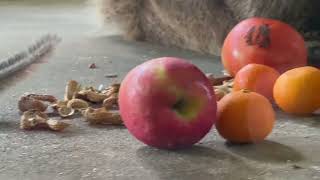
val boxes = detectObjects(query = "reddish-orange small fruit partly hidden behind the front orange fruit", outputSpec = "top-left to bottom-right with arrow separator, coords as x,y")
233,64 -> 280,101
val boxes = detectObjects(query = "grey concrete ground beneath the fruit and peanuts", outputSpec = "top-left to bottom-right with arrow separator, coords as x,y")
0,1 -> 320,180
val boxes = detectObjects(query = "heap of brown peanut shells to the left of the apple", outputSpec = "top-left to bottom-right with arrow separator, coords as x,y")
18,80 -> 123,131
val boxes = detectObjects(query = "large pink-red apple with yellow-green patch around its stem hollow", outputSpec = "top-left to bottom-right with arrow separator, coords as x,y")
119,57 -> 217,149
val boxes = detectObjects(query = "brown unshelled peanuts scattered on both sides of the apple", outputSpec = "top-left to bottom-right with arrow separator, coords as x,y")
18,74 -> 233,131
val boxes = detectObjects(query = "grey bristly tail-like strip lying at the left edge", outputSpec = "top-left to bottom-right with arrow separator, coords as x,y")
0,34 -> 61,79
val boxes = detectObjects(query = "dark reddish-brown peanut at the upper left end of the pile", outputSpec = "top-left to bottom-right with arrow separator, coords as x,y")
18,96 -> 48,112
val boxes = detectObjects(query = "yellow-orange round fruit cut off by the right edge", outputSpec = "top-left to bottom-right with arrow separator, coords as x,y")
273,66 -> 320,115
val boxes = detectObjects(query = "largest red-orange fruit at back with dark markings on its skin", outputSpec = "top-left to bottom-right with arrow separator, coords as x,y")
221,17 -> 308,76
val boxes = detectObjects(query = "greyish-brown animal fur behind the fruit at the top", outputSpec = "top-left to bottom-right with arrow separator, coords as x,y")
97,0 -> 320,54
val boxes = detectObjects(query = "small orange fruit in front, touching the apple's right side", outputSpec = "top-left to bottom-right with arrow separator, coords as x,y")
216,90 -> 275,143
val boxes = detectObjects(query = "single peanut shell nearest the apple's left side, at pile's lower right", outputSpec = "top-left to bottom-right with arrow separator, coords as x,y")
83,107 -> 123,125
